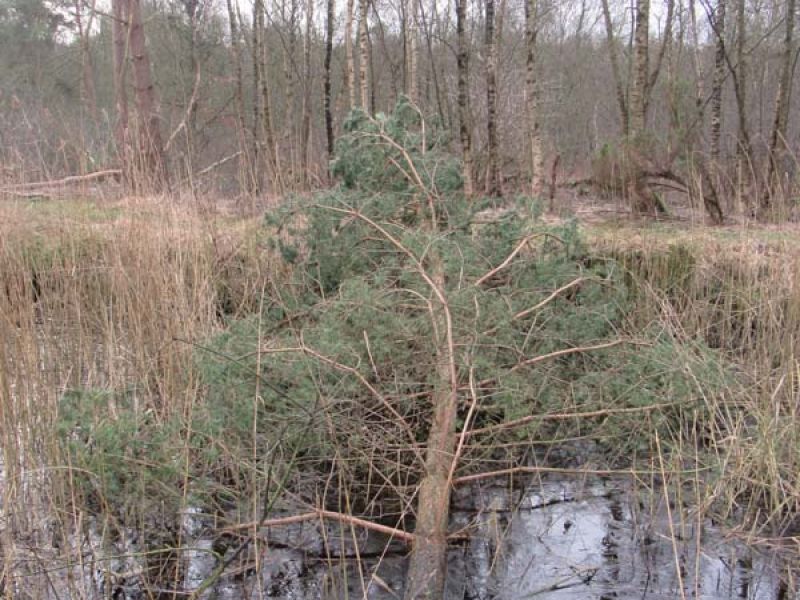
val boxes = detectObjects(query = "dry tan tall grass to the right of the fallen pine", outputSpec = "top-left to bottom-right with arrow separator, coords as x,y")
592,228 -> 800,541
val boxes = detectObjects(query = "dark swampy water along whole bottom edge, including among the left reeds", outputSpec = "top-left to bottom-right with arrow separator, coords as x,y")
0,477 -> 800,600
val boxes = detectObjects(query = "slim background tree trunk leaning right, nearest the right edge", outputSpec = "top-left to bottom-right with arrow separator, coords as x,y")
761,0 -> 797,210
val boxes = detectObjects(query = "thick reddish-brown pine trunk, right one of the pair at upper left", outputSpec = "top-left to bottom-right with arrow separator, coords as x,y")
127,0 -> 167,190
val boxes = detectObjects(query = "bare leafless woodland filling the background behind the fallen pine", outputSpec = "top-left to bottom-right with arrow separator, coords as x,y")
0,0 -> 798,218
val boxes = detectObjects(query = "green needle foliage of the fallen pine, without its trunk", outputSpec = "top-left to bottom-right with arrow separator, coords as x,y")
199,102 -> 736,492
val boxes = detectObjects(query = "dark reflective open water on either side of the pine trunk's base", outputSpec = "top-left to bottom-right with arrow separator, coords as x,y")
186,479 -> 800,600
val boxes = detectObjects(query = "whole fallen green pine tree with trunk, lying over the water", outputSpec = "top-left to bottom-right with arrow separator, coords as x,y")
201,101 -> 724,599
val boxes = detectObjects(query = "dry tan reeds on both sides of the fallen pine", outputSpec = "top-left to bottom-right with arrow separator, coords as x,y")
0,192 -> 800,597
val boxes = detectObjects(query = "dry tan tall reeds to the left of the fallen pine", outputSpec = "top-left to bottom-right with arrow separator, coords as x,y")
0,198 -> 276,597
